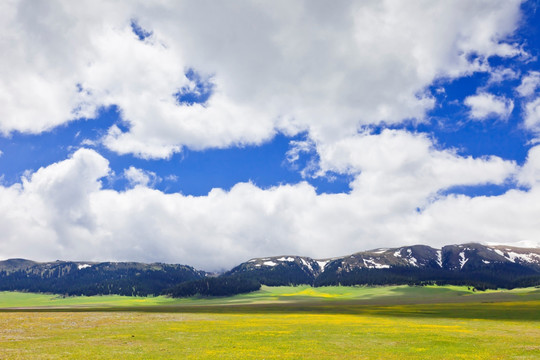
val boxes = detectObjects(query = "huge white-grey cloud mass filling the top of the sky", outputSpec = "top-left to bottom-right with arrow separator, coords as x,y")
0,0 -> 522,158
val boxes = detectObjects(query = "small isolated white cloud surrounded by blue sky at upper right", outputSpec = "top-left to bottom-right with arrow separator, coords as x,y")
464,92 -> 514,120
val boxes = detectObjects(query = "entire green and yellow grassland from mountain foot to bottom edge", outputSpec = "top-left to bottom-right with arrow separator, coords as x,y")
0,287 -> 540,359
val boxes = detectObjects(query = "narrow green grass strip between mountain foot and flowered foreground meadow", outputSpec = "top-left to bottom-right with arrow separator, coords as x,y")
0,285 -> 540,309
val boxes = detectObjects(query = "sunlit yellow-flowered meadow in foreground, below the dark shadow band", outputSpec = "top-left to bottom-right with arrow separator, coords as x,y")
0,312 -> 540,359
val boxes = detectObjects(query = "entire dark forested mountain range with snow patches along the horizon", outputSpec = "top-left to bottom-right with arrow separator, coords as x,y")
0,243 -> 540,296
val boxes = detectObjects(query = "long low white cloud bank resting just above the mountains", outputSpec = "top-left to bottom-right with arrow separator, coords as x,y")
0,145 -> 528,270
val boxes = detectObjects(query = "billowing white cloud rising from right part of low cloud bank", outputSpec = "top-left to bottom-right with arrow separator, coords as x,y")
319,130 -> 516,205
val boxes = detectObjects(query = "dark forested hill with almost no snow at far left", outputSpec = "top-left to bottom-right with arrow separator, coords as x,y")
0,259 -> 205,296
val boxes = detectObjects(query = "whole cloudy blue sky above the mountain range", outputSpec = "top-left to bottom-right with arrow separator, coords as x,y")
0,0 -> 540,271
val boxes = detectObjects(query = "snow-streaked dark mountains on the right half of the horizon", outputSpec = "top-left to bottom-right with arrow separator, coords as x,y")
226,243 -> 540,288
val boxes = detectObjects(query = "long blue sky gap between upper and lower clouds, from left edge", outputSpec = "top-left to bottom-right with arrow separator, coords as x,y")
0,107 -> 350,196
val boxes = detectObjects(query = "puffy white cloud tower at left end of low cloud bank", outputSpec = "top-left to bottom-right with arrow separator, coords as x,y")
0,149 -> 109,260
